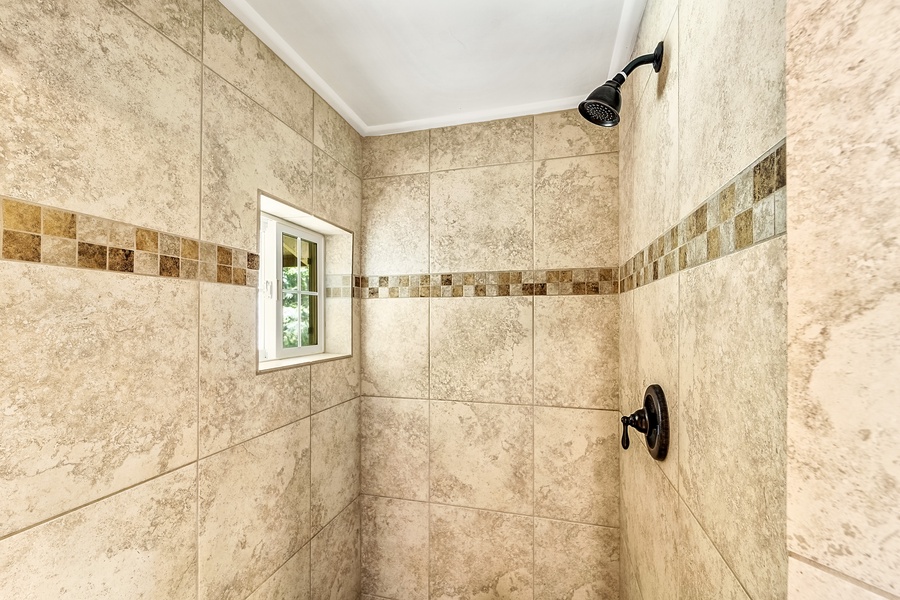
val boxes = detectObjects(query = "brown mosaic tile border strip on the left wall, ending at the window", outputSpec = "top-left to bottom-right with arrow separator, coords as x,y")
0,198 -> 259,287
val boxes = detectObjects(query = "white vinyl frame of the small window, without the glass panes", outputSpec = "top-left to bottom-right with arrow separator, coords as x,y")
259,213 -> 325,362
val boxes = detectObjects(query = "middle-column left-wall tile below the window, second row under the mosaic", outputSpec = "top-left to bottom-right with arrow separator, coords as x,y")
198,419 -> 310,598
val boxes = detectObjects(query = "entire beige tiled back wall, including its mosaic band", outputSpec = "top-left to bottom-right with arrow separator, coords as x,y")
360,111 -> 619,600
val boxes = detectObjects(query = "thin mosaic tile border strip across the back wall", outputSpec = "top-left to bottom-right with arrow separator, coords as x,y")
353,267 -> 619,299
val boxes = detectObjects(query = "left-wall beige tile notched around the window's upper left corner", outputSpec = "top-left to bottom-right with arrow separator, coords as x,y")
202,69 -> 313,252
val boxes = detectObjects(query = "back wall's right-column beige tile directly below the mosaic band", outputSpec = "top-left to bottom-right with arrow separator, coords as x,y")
534,296 -> 619,410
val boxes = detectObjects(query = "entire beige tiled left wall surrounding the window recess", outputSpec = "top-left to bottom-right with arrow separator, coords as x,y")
0,0 -> 362,600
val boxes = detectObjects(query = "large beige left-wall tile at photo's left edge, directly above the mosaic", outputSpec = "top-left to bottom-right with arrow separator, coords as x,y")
0,0 -> 200,238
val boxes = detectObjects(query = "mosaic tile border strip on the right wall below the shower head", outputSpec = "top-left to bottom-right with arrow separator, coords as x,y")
619,141 -> 787,292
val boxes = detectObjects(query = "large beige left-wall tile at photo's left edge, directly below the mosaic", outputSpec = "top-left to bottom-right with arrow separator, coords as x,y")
0,262 -> 198,536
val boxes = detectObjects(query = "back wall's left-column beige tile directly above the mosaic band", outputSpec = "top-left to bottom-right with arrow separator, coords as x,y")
362,173 -> 429,275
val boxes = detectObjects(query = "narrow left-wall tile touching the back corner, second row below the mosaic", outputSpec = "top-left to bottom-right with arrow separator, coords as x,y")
310,399 -> 359,535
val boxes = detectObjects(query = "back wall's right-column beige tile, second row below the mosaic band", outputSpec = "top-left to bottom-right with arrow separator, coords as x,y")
534,407 -> 619,527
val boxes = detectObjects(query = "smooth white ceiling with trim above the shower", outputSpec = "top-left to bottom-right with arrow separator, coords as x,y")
222,0 -> 646,135
